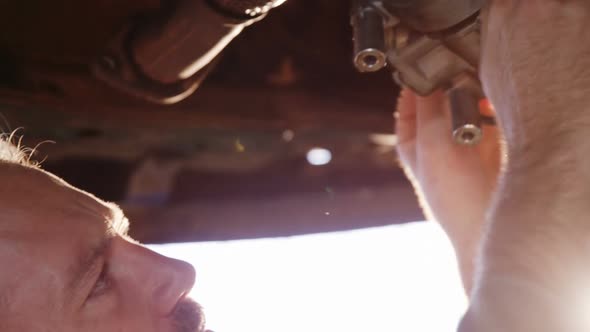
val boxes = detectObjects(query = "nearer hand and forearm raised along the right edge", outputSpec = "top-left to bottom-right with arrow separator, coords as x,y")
460,0 -> 590,332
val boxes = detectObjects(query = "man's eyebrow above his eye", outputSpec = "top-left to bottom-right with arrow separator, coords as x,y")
65,237 -> 113,305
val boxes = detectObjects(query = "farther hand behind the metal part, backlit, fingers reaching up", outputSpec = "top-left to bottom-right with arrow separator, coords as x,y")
396,90 -> 500,292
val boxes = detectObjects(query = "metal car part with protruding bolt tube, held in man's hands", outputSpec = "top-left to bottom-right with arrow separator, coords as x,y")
353,0 -> 484,145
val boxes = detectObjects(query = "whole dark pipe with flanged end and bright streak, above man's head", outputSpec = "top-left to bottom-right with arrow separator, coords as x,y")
92,0 -> 279,104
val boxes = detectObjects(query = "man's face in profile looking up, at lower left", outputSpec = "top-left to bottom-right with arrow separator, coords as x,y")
0,165 -> 203,332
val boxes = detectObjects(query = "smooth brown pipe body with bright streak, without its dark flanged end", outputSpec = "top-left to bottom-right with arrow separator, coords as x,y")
130,0 -> 260,83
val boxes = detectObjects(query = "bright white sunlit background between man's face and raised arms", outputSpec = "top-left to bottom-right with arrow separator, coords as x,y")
150,222 -> 467,332
